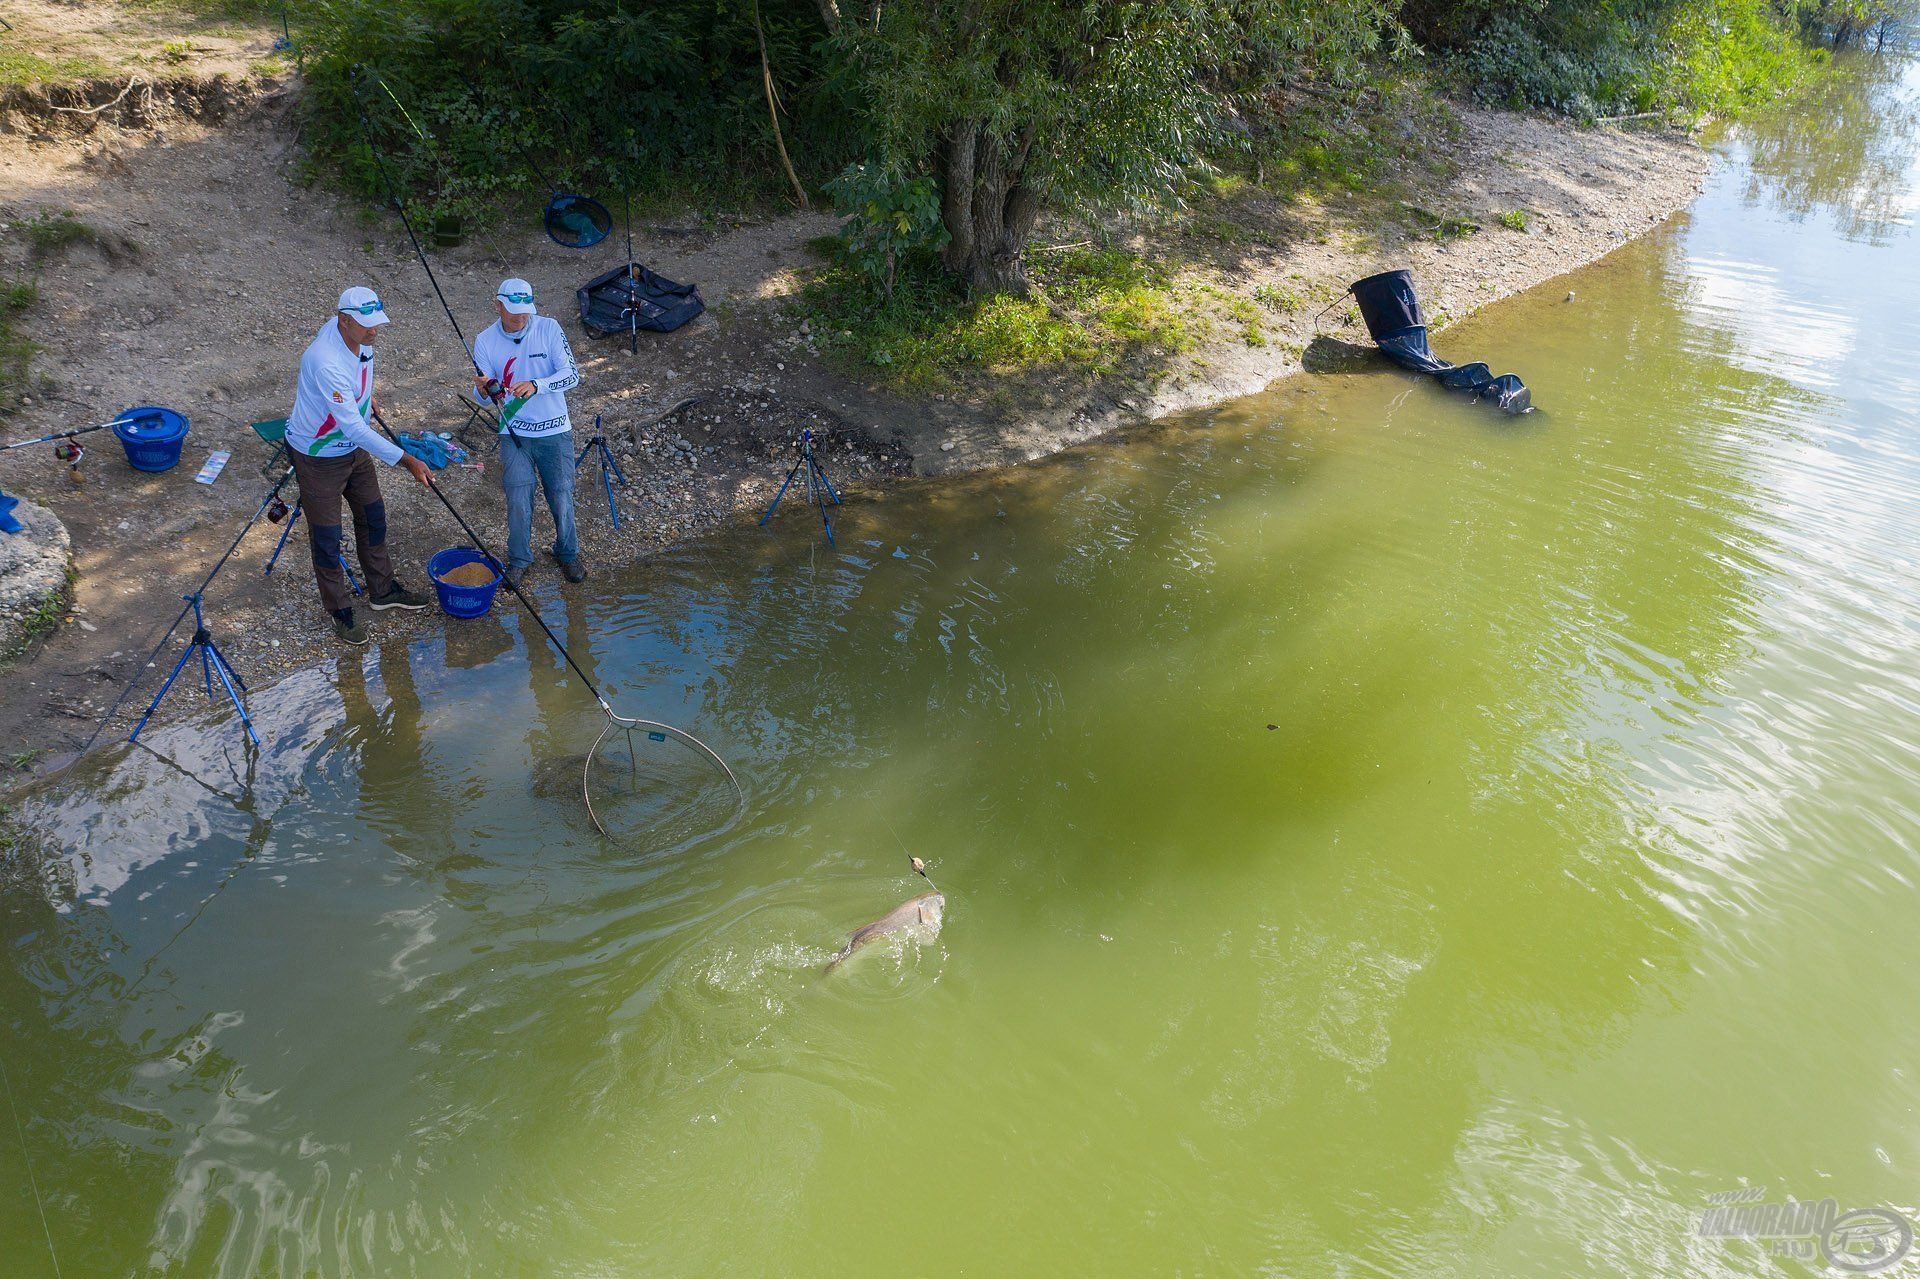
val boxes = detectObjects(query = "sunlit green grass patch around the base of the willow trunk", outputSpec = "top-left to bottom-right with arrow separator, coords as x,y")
797,248 -> 1204,394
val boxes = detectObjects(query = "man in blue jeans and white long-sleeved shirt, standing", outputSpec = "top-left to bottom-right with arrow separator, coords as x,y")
474,278 -> 588,586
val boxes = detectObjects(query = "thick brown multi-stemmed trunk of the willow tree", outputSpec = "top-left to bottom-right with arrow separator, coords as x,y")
937,121 -> 1041,298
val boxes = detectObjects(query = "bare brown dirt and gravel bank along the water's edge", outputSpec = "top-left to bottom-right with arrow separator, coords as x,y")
0,74 -> 1705,776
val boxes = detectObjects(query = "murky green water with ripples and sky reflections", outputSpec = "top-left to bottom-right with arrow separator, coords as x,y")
0,57 -> 1920,1277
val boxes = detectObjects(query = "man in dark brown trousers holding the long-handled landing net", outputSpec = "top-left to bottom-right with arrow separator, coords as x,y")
286,286 -> 432,643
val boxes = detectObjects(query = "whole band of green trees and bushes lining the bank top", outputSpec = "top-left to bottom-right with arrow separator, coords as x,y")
299,0 -> 1858,294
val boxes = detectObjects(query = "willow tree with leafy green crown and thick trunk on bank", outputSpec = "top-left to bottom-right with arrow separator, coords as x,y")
818,0 -> 1392,294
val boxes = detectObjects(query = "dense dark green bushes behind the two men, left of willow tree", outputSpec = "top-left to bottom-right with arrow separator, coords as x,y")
294,0 -> 862,217
